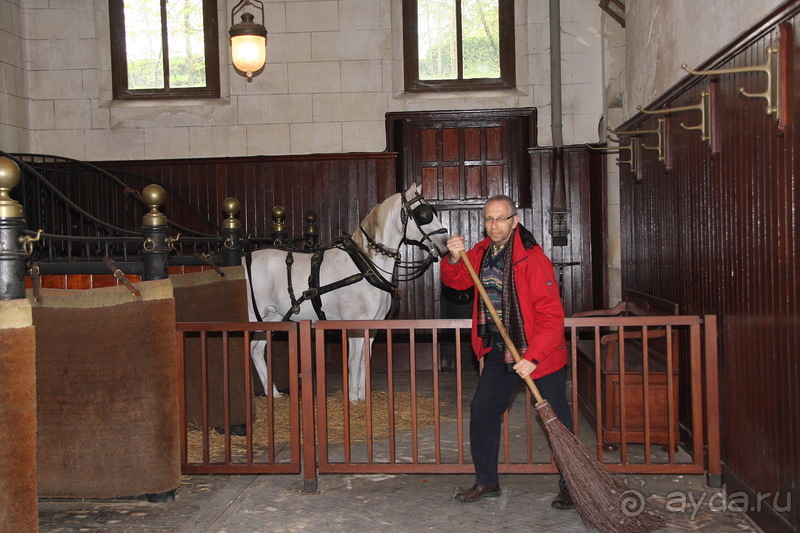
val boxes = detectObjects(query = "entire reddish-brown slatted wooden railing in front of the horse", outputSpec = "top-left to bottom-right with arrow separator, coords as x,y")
173,316 -> 720,487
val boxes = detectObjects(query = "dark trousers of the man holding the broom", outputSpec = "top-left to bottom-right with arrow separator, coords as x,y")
469,342 -> 573,487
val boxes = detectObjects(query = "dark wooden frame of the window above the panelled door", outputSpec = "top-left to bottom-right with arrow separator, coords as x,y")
403,0 -> 517,92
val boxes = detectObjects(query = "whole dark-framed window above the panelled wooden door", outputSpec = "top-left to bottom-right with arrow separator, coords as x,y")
403,0 -> 516,92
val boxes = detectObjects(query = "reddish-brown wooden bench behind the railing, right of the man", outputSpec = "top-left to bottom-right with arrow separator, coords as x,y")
572,290 -> 679,451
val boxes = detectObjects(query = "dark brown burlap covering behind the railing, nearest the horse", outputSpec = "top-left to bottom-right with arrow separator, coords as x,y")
172,266 -> 258,428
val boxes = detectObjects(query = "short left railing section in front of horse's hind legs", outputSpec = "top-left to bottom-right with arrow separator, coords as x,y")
177,322 -> 310,474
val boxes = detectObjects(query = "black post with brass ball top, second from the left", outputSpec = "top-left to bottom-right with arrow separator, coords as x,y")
142,184 -> 174,281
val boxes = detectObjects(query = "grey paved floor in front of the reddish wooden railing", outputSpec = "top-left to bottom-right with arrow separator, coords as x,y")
39,474 -> 760,533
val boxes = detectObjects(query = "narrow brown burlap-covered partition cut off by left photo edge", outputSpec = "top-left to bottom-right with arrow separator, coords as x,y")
0,299 -> 39,532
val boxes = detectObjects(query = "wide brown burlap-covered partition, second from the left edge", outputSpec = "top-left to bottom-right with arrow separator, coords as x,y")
29,279 -> 180,498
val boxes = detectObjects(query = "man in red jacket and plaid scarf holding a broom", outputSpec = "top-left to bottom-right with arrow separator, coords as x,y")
441,195 -> 573,509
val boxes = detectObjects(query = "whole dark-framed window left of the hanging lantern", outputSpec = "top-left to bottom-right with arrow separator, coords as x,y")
109,0 -> 219,99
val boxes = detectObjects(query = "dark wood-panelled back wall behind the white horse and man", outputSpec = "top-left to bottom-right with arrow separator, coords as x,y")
96,115 -> 603,318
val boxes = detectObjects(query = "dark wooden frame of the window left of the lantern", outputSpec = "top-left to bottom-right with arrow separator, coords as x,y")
108,0 -> 220,100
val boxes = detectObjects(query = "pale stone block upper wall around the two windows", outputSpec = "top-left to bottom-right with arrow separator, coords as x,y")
0,0 -> 602,161
